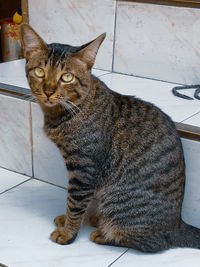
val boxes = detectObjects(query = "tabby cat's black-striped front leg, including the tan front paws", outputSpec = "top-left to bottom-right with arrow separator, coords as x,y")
51,174 -> 94,245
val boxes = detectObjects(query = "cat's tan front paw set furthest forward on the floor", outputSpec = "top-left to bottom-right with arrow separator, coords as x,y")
51,227 -> 77,245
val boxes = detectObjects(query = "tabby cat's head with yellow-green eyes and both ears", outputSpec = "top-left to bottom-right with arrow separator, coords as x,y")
21,24 -> 105,107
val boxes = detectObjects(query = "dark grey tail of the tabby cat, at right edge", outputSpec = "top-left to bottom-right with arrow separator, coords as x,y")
167,221 -> 200,249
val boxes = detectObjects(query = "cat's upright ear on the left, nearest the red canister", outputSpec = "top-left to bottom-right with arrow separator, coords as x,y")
20,23 -> 48,59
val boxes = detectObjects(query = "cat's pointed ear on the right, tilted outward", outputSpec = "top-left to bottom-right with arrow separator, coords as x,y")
76,33 -> 106,68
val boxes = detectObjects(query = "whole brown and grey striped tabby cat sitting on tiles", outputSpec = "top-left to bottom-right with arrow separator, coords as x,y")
21,24 -> 200,252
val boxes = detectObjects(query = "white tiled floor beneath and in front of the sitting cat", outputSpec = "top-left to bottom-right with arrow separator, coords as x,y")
0,170 -> 200,267
